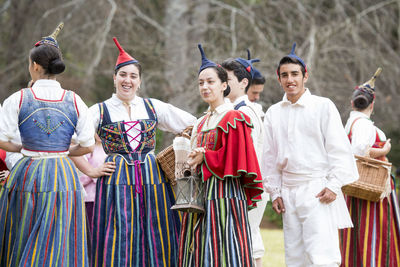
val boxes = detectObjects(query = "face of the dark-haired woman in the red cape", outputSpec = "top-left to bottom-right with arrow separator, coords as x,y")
198,68 -> 227,109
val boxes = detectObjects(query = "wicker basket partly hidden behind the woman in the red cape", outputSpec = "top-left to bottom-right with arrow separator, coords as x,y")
156,126 -> 193,185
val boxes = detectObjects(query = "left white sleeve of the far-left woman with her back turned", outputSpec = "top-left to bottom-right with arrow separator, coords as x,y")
0,91 -> 21,142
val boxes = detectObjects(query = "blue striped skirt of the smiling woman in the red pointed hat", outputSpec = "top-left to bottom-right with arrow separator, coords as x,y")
91,154 -> 181,267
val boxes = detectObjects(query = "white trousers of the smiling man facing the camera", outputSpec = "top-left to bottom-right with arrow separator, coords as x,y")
282,179 -> 341,267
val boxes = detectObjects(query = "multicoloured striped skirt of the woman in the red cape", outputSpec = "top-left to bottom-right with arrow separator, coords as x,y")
179,176 -> 253,267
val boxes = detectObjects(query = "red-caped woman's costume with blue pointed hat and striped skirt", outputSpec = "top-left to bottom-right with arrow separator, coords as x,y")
178,45 -> 263,266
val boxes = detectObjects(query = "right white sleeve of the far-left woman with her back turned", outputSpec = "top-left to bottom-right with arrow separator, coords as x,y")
75,95 -> 95,147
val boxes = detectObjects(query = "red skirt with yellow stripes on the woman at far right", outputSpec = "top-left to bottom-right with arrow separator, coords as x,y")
340,177 -> 400,267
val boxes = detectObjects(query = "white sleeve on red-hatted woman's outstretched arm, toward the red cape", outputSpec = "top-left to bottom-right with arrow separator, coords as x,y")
151,98 -> 196,134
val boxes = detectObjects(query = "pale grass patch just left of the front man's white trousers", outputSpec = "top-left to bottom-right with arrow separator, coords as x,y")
261,228 -> 285,267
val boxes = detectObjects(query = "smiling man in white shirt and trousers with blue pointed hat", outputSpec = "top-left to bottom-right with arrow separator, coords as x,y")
260,44 -> 358,267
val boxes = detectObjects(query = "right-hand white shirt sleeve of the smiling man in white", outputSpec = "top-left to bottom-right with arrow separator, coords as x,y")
321,100 -> 358,194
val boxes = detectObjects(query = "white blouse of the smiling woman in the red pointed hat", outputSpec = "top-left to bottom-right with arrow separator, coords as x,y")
89,94 -> 196,153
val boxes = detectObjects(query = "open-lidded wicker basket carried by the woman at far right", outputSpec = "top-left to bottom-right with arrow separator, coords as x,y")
342,156 -> 392,202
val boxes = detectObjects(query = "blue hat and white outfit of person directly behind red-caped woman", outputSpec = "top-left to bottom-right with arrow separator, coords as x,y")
233,50 -> 269,259
